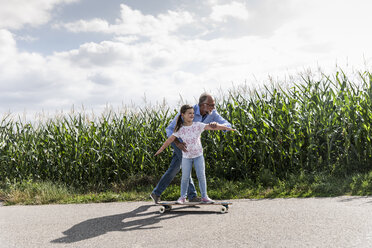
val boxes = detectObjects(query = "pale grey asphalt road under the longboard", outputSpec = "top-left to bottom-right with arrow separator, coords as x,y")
0,197 -> 372,248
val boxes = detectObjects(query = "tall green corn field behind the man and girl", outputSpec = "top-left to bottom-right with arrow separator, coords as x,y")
0,72 -> 372,187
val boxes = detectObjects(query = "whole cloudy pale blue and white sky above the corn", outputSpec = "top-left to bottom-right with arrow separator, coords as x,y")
0,0 -> 372,119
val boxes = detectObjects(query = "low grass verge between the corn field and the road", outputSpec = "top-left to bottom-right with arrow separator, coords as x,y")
0,171 -> 372,205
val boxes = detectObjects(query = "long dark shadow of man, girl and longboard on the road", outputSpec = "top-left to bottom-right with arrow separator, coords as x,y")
51,205 -> 216,243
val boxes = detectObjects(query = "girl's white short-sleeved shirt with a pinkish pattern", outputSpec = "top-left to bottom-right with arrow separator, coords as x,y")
172,122 -> 206,158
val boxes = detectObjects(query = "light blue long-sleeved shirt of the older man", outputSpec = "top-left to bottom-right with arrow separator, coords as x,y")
165,104 -> 231,138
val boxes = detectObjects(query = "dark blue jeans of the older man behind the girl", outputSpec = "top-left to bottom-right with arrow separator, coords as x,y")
152,142 -> 197,199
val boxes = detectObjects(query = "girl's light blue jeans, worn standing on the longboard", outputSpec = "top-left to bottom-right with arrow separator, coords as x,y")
181,155 -> 207,197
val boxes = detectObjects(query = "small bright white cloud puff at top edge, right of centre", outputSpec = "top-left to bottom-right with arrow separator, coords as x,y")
210,2 -> 249,22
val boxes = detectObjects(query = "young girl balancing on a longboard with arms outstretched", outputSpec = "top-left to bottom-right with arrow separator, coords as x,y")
155,104 -> 236,204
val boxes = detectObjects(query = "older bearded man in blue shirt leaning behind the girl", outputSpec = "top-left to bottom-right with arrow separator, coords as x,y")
150,93 -> 231,203
